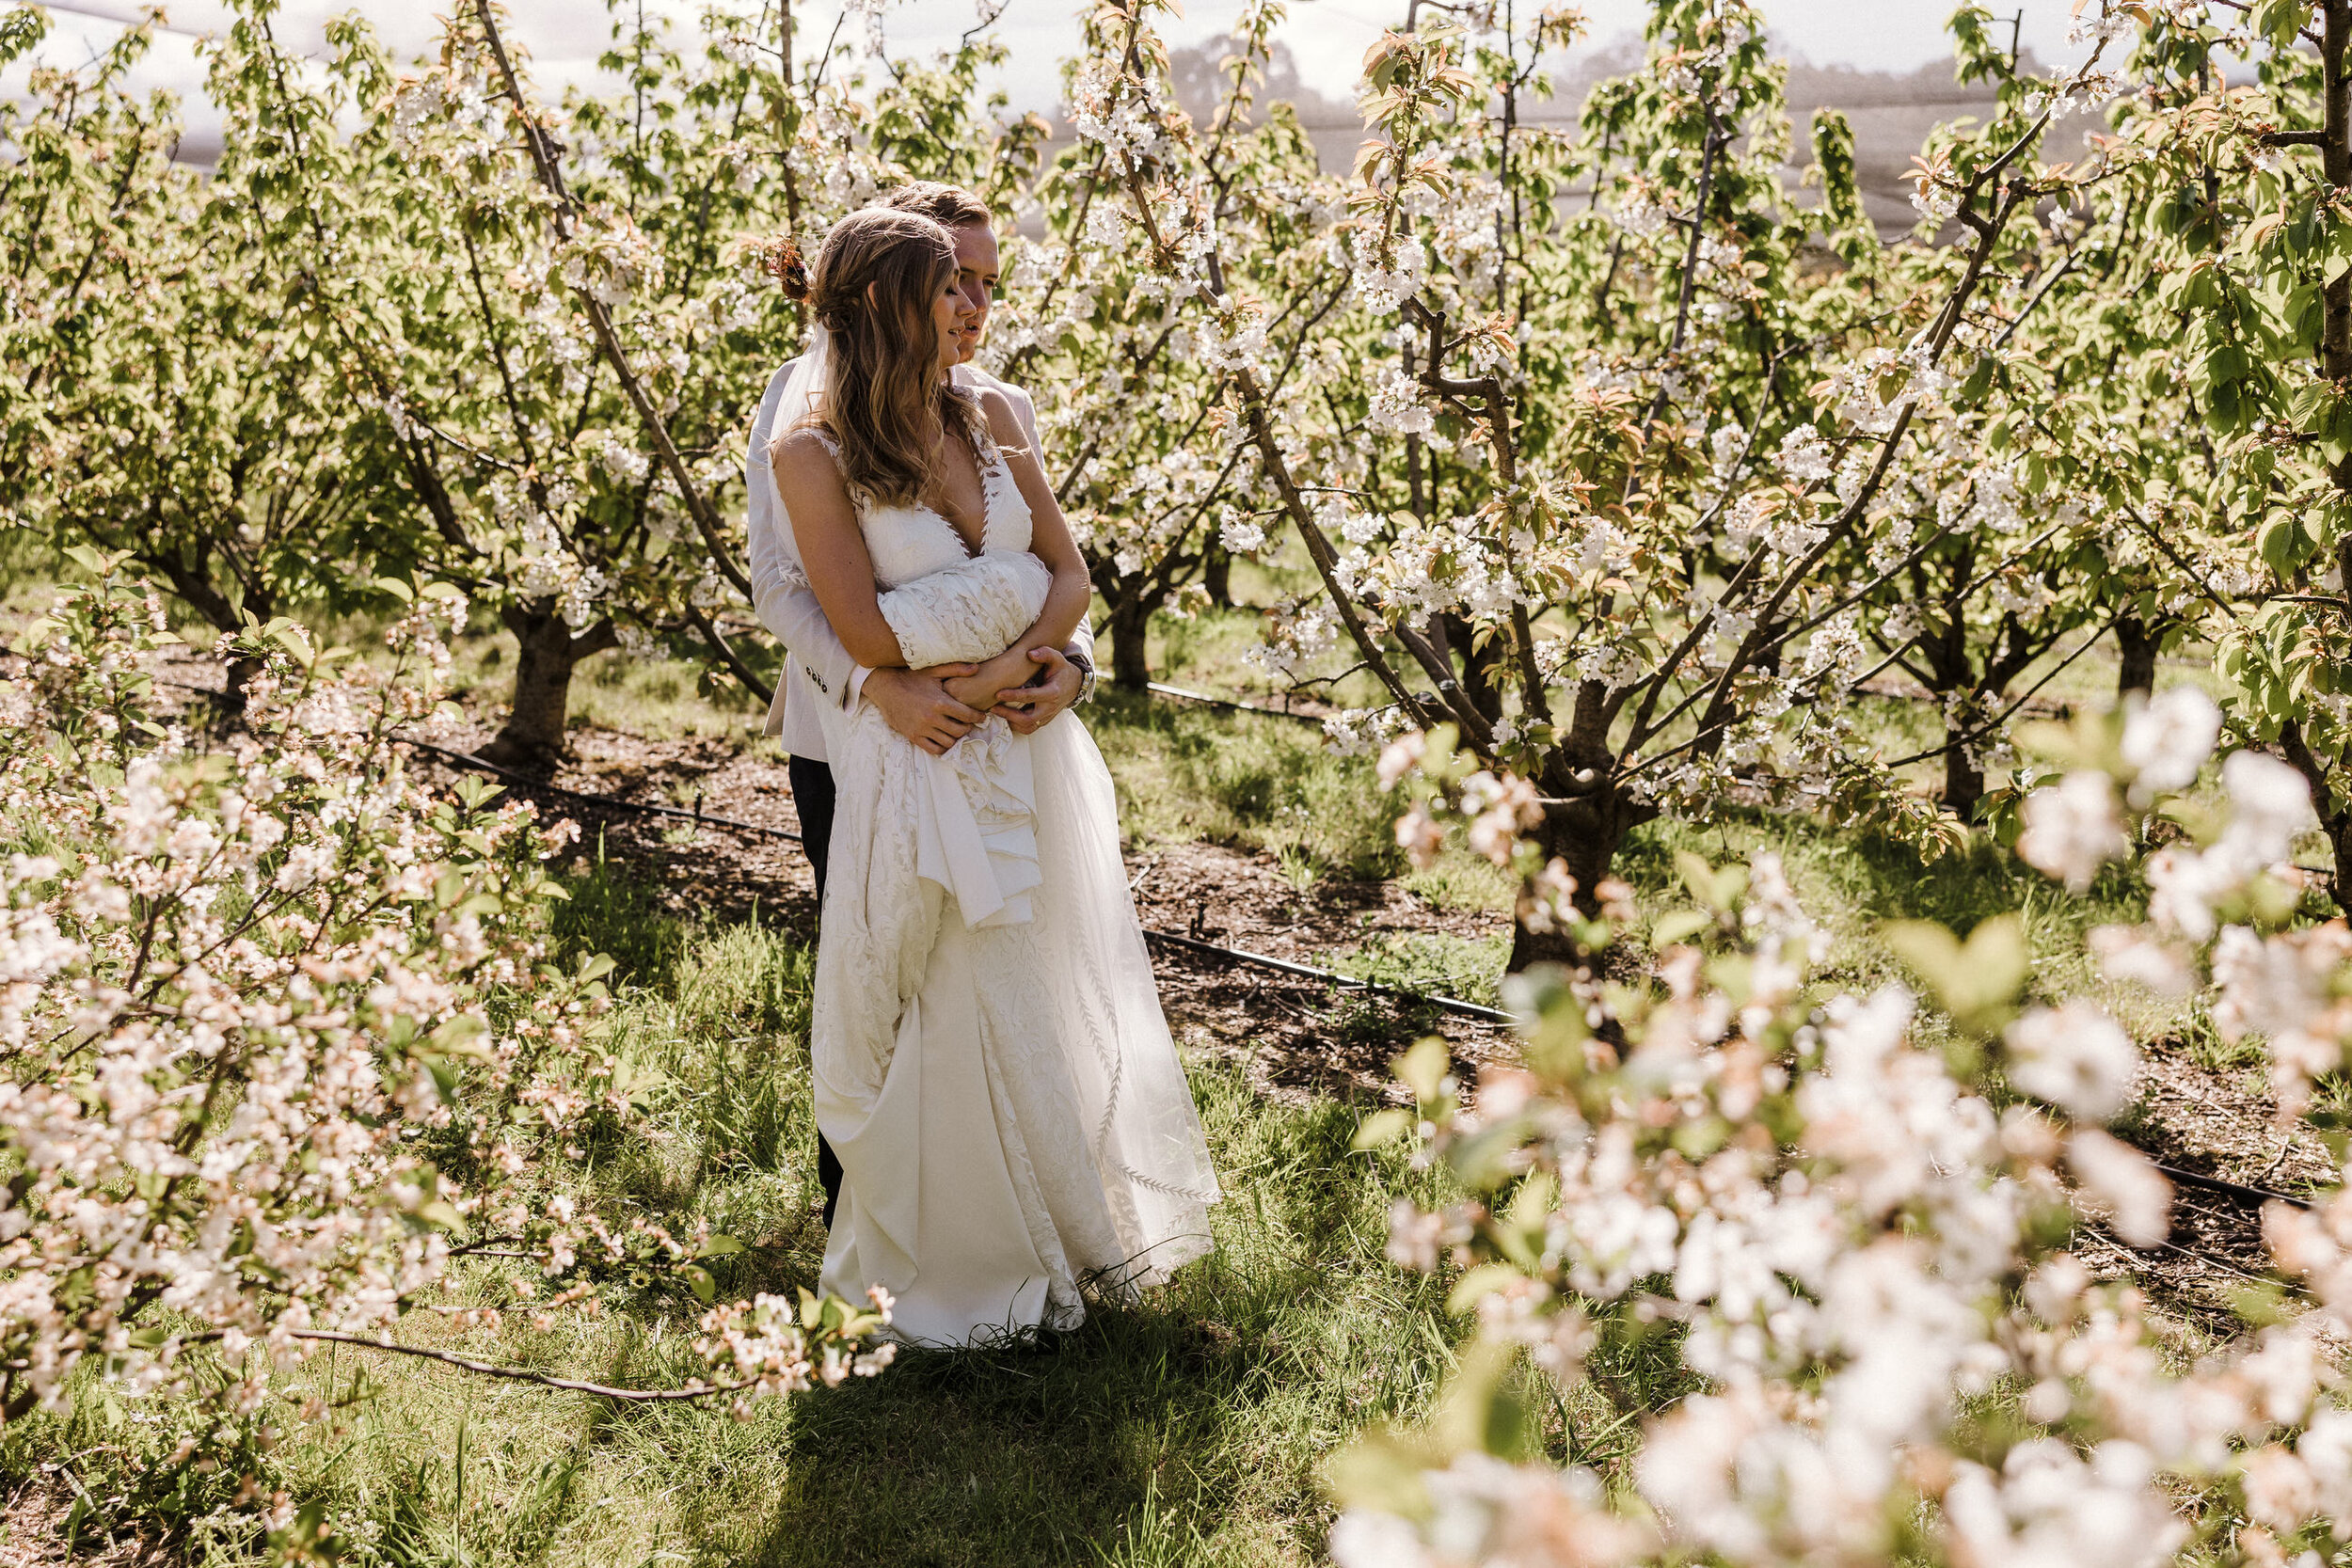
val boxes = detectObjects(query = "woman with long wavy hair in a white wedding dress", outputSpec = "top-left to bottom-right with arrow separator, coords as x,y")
770,209 -> 1218,1345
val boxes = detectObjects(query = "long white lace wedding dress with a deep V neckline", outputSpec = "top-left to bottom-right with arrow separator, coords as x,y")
812,420 -> 1218,1345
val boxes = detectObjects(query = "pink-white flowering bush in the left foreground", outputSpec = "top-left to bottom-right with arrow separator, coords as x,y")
0,560 -> 889,1476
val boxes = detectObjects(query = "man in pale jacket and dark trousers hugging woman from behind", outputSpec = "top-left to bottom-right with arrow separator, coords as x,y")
743,181 -> 1094,1227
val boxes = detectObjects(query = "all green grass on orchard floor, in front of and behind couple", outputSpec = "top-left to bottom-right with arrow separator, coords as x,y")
0,545 -> 2296,1568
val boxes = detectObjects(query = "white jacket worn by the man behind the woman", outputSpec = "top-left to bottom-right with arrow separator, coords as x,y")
743,359 -> 1094,762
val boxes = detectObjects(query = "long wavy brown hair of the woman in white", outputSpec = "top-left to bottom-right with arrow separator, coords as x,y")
774,207 -> 988,505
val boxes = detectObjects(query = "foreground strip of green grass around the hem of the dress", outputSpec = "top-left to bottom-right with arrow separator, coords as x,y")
37,863 -> 1461,1568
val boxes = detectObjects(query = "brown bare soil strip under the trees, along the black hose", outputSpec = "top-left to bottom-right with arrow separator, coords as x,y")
395,729 -> 2336,1338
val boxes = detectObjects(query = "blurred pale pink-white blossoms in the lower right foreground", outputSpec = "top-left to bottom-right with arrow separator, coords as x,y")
1331,693 -> 2352,1568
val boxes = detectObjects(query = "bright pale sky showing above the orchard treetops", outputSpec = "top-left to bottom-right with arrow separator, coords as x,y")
0,0 -> 2079,146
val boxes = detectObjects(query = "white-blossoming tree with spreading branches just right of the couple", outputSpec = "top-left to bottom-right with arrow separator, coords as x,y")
1073,0 -> 2145,966
